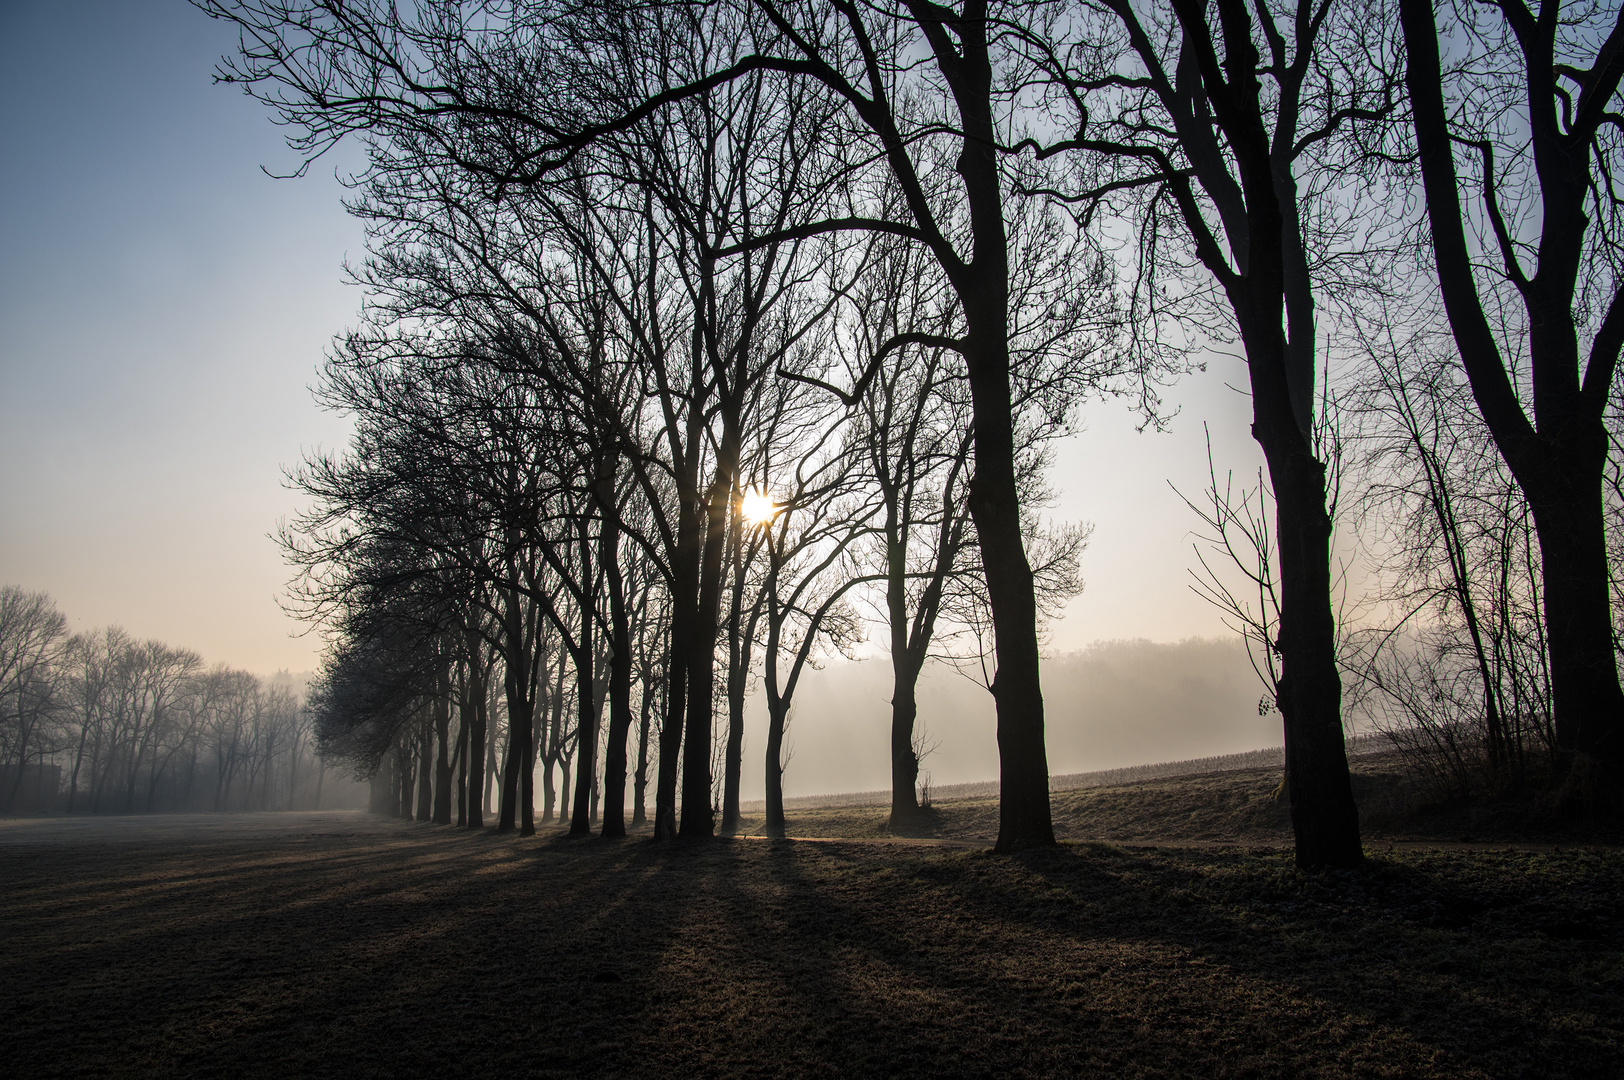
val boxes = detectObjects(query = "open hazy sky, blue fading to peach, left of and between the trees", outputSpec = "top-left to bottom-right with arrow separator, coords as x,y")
0,0 -> 1260,672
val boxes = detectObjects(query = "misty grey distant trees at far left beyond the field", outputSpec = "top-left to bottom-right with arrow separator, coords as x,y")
0,586 -> 325,814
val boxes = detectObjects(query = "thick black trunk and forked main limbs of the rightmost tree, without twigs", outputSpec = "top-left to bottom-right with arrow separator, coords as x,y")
1400,0 -> 1624,810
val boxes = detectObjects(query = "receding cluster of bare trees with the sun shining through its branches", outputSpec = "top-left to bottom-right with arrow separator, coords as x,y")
272,27 -> 1114,836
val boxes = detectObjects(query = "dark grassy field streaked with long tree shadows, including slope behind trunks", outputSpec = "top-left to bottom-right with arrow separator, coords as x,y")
0,763 -> 1624,1077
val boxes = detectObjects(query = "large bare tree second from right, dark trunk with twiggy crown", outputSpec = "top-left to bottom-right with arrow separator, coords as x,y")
1025,0 -> 1397,866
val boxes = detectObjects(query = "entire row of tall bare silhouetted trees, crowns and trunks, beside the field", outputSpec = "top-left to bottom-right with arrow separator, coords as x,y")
198,0 -> 1624,866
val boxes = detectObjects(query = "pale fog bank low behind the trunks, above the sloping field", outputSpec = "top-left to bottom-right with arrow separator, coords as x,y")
723,638 -> 1281,799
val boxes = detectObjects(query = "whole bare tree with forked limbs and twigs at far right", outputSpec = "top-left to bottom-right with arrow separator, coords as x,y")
1400,0 -> 1624,810
